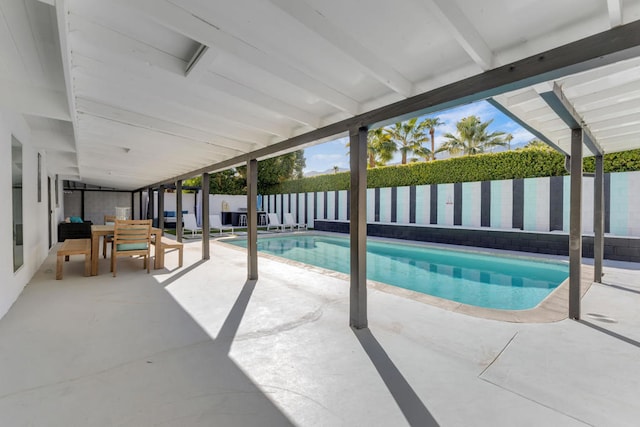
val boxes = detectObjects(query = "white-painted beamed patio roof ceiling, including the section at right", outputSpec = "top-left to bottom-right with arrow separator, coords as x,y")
0,0 -> 640,189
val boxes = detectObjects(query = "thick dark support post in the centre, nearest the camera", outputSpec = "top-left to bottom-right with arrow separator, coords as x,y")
349,127 -> 368,329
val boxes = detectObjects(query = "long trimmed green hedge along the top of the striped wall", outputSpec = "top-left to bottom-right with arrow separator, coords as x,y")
265,148 -> 640,194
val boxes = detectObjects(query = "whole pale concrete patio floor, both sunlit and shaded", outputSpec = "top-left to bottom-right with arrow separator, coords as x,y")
0,241 -> 640,426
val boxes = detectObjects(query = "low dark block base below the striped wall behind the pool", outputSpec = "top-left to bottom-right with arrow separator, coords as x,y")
314,220 -> 640,262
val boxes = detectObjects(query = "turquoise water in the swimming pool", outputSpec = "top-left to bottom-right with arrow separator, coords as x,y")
228,235 -> 569,310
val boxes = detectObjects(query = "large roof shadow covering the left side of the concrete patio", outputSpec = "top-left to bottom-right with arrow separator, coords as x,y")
0,251 -> 292,426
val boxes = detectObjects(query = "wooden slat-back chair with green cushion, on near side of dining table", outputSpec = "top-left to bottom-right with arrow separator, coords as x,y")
111,219 -> 151,277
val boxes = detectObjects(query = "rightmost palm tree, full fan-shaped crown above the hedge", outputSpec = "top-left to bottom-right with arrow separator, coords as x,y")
441,116 -> 506,155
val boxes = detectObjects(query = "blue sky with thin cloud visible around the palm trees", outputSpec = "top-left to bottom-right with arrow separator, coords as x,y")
304,101 -> 534,173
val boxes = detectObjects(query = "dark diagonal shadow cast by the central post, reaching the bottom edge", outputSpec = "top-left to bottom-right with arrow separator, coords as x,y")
352,328 -> 439,426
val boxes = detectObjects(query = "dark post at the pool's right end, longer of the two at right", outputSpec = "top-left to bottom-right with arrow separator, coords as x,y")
569,128 -> 582,320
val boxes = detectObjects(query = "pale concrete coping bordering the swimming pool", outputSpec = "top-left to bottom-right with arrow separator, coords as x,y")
212,231 -> 593,323
